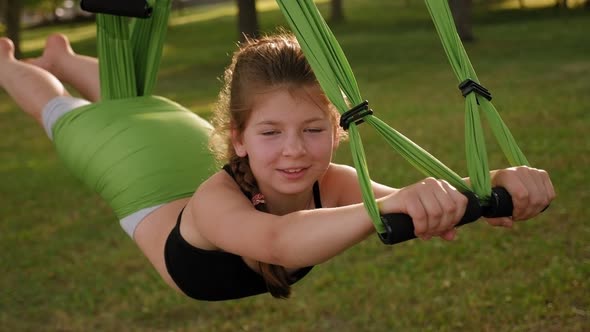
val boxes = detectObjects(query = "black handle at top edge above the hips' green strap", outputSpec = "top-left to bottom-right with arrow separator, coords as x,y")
80,0 -> 152,18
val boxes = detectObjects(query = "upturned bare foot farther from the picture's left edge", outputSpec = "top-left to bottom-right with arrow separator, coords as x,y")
26,33 -> 75,78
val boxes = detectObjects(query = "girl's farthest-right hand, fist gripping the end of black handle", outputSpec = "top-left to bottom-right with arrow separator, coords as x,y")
487,166 -> 555,227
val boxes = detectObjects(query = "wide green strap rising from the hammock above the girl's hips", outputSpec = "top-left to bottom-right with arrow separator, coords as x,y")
96,0 -> 171,100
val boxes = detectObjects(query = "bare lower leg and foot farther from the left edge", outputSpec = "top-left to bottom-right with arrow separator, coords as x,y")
27,34 -> 100,102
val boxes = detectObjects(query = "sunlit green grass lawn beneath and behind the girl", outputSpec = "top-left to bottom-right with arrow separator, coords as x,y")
0,0 -> 590,331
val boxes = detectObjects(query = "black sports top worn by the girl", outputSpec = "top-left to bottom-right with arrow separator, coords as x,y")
164,166 -> 322,301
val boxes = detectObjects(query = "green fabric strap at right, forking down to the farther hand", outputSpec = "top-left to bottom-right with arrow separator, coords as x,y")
426,0 -> 528,201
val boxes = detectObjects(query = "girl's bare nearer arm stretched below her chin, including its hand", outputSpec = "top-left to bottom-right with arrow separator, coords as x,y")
187,165 -> 466,268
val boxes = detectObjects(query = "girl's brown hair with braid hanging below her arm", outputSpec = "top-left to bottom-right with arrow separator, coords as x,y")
210,32 -> 343,298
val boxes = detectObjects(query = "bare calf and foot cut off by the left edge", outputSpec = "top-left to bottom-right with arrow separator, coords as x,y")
0,38 -> 69,123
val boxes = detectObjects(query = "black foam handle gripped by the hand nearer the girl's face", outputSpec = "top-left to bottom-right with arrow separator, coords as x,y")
378,192 -> 481,244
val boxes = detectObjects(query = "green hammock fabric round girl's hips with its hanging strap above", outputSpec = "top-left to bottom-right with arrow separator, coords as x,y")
52,0 -> 215,223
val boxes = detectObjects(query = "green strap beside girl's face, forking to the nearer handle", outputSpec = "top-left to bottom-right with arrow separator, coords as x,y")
277,0 -> 470,233
